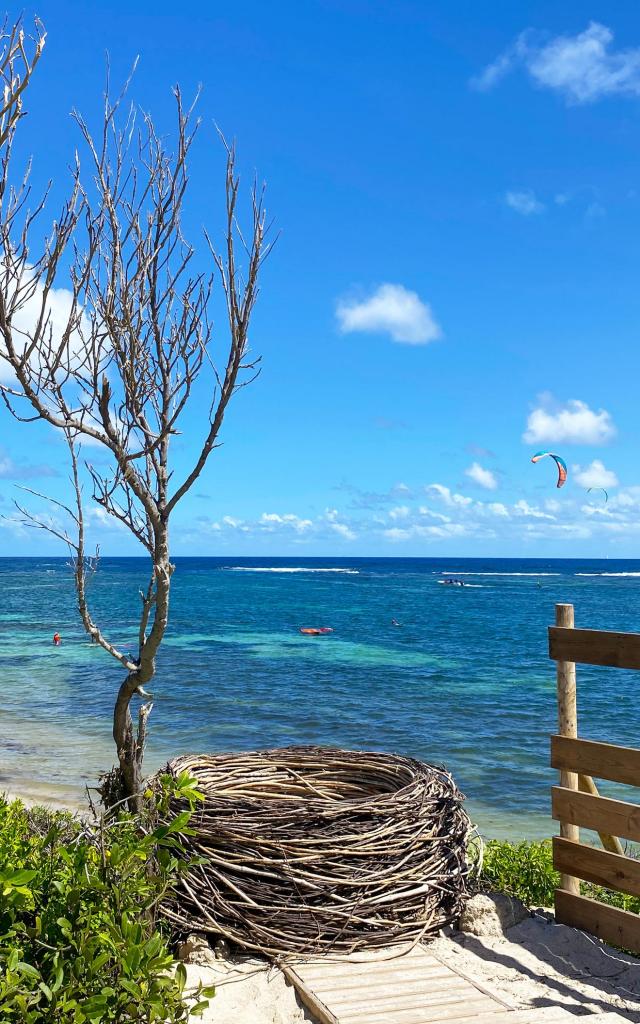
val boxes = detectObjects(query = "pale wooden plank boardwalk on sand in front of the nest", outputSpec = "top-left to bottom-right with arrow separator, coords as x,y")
285,946 -> 625,1024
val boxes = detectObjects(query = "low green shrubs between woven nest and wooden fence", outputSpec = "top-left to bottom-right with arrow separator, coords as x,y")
480,840 -> 640,913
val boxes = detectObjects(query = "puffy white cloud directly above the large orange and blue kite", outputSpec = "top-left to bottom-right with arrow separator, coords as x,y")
522,395 -> 616,444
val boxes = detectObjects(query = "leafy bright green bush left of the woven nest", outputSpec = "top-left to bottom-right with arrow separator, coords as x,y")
0,775 -> 213,1024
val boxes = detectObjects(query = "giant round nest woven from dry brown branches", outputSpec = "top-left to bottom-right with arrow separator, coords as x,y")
159,746 -> 470,956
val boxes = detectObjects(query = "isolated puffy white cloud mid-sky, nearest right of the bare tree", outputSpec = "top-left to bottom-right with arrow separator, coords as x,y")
336,285 -> 442,345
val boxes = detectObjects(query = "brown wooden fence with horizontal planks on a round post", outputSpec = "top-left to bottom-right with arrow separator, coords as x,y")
549,604 -> 640,952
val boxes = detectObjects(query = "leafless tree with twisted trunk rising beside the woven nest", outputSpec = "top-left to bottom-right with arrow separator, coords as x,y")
0,49 -> 273,809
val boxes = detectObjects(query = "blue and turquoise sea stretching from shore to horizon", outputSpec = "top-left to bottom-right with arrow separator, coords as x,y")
0,558 -> 640,837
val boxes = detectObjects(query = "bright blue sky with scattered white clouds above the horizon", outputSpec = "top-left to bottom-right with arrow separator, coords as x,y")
0,0 -> 640,557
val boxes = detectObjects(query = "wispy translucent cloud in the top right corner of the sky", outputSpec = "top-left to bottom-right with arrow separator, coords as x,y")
471,22 -> 640,103
